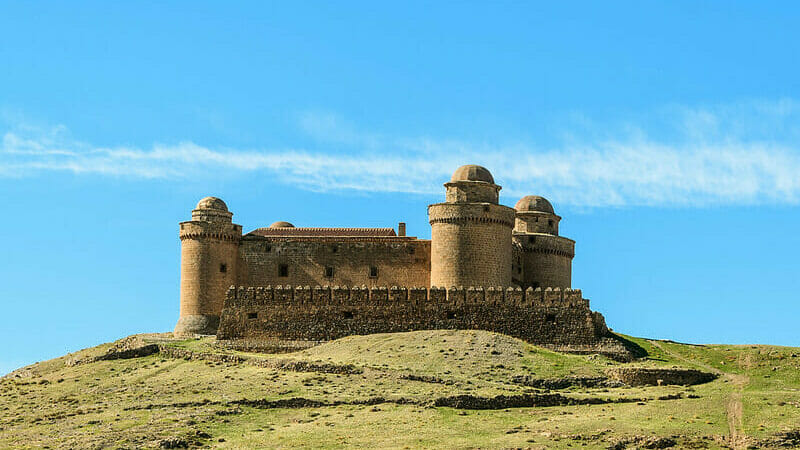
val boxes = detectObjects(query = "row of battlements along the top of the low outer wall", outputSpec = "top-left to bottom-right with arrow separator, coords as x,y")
225,285 -> 589,309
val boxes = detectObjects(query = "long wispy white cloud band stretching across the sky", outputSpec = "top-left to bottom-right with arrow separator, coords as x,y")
0,100 -> 800,207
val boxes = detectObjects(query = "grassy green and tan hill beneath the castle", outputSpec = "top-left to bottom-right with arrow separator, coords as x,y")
0,331 -> 800,448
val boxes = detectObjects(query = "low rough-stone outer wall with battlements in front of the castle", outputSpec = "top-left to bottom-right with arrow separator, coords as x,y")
217,286 -> 609,348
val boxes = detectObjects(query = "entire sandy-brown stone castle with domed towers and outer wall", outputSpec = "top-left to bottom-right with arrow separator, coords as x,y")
175,165 -> 619,353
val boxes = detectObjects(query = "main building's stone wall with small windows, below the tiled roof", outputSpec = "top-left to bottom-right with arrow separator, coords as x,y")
238,236 -> 431,286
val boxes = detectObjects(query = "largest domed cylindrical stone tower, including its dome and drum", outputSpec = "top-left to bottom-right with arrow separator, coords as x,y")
428,165 -> 514,287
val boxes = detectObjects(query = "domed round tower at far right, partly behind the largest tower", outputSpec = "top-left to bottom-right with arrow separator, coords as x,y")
514,195 -> 575,289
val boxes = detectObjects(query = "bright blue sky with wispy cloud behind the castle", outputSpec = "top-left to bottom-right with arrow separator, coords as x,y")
0,1 -> 800,373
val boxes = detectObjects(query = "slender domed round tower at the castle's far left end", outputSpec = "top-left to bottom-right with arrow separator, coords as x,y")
174,197 -> 242,336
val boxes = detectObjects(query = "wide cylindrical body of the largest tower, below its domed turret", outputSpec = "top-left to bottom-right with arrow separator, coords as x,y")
428,203 -> 514,287
